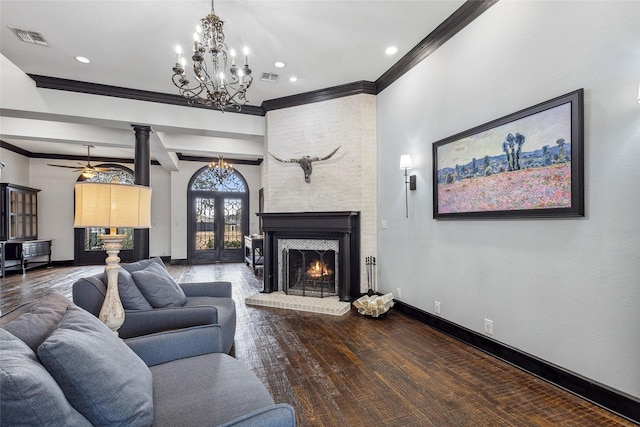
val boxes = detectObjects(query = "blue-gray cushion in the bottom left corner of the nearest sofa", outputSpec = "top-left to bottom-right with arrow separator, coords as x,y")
0,329 -> 91,426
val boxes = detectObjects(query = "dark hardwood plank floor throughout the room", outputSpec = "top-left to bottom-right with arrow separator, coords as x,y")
0,264 -> 635,426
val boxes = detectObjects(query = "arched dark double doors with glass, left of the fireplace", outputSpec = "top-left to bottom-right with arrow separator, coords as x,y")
187,166 -> 249,264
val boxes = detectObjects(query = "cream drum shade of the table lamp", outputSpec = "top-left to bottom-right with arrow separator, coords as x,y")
73,182 -> 151,228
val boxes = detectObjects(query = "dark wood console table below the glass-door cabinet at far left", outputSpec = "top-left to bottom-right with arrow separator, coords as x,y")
0,239 -> 52,277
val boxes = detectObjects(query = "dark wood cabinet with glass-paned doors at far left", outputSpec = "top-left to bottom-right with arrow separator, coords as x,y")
0,183 -> 40,241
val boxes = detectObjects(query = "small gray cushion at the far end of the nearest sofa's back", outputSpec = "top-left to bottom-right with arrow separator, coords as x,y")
4,291 -> 71,351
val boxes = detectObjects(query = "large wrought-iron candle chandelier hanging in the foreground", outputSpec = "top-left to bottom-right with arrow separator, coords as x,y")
172,0 -> 253,111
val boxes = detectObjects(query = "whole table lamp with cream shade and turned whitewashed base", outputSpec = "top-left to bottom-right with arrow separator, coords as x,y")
73,182 -> 151,335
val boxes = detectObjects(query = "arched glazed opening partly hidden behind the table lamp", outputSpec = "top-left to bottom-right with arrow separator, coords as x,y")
74,163 -> 135,265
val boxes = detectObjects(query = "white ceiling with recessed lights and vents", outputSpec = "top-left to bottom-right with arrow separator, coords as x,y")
0,0 -> 464,164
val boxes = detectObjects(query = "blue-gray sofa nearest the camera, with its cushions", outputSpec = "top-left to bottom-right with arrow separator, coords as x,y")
0,291 -> 295,427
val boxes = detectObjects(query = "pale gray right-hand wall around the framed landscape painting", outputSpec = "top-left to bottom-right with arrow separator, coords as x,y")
378,0 -> 640,397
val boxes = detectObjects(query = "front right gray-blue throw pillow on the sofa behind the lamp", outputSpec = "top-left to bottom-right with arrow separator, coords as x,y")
131,263 -> 187,308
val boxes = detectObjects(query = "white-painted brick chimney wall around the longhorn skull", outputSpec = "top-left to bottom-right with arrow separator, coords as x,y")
262,94 -> 377,292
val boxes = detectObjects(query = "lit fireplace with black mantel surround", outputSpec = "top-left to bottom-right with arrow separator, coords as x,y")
258,211 -> 360,301
